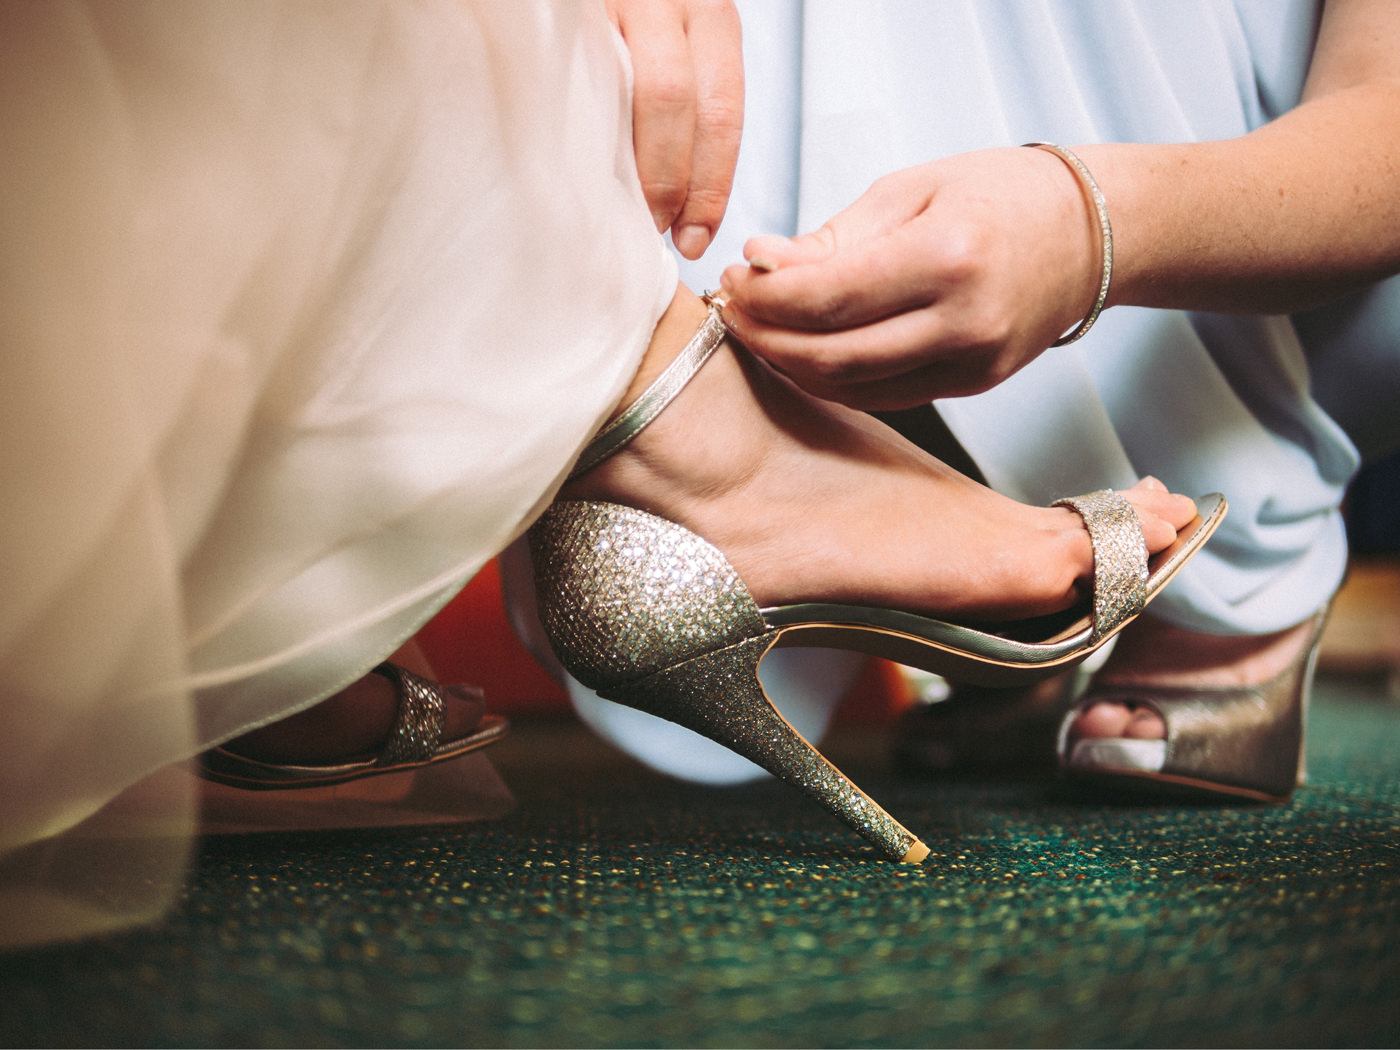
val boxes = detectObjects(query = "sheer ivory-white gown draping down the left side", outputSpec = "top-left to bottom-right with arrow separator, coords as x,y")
0,0 -> 675,942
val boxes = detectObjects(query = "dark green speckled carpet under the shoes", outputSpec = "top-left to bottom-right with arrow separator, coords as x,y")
0,682 -> 1400,1046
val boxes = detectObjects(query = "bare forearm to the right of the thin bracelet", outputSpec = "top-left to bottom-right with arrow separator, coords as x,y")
1077,3 -> 1400,312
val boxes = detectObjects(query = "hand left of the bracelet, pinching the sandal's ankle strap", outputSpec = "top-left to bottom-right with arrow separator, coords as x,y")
722,147 -> 1099,409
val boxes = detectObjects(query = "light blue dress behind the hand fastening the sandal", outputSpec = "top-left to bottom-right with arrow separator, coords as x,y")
683,0 -> 1400,633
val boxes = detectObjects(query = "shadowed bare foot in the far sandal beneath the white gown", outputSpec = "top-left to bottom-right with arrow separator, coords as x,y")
225,641 -> 484,764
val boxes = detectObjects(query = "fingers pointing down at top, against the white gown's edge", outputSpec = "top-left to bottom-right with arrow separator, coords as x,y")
608,0 -> 743,259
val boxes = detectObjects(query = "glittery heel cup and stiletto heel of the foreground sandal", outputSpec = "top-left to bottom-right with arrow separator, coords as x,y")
531,503 -> 923,860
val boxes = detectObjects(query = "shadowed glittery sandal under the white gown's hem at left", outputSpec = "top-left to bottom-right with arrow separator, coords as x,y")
196,664 -> 510,791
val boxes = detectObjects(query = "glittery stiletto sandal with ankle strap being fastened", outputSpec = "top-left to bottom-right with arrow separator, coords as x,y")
529,302 -> 1225,864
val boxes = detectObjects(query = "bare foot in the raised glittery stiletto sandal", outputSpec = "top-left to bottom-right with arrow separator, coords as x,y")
563,291 -> 1196,620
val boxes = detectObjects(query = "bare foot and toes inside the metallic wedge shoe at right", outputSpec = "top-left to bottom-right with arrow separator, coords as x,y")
1070,616 -> 1316,741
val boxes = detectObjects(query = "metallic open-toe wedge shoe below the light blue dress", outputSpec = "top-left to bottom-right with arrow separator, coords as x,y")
1058,609 -> 1327,802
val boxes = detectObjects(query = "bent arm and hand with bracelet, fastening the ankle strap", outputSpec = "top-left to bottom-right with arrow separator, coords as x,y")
722,0 -> 1400,409
